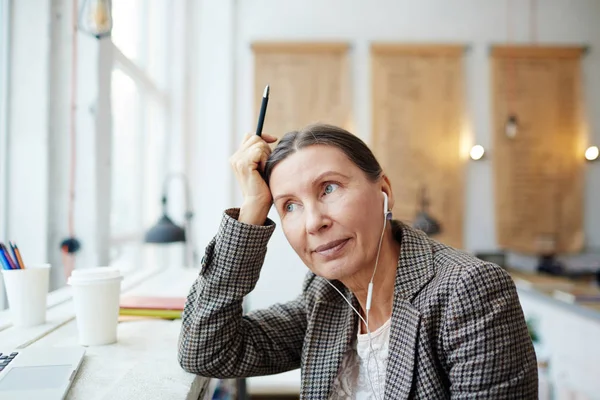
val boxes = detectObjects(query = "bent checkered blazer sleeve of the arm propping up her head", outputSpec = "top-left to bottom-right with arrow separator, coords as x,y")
178,209 -> 306,379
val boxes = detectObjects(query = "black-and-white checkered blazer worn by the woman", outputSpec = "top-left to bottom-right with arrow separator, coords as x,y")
179,209 -> 538,400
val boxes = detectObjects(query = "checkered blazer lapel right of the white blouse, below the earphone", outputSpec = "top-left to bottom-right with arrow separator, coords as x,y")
385,223 -> 434,399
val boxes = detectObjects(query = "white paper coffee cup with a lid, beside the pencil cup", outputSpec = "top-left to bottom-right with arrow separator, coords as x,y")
69,267 -> 123,346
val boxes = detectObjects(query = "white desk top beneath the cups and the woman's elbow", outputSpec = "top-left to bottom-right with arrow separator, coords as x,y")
0,268 -> 211,400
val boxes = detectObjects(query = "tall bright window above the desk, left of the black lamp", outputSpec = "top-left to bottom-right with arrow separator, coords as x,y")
110,0 -> 183,268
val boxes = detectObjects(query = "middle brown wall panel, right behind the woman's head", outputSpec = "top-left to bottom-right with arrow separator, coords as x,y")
371,44 -> 465,248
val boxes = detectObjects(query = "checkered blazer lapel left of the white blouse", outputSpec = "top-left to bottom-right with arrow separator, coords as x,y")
300,283 -> 358,399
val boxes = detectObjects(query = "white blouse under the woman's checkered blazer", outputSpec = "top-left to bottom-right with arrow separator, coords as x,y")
329,318 -> 391,400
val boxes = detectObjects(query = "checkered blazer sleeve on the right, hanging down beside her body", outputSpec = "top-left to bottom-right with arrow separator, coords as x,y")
442,264 -> 538,400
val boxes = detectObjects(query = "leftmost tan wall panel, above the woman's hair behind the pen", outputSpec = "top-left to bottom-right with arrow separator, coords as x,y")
252,42 -> 352,136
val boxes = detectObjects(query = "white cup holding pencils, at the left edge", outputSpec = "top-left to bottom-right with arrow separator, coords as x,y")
2,264 -> 50,327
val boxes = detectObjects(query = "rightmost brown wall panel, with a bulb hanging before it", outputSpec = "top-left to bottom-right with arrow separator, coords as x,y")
491,47 -> 583,254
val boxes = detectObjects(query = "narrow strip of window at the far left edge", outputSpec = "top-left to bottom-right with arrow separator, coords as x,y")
0,0 -> 10,239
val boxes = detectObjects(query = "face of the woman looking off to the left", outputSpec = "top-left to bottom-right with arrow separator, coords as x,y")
269,145 -> 393,280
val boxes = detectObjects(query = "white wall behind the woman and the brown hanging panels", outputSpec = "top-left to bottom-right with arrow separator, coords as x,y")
189,0 -> 600,308
